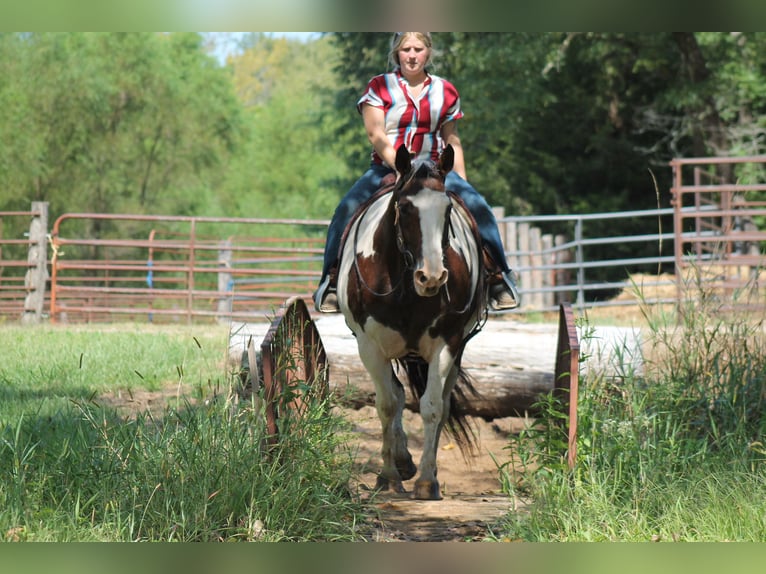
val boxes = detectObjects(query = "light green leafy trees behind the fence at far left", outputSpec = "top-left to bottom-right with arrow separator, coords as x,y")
0,33 -> 242,228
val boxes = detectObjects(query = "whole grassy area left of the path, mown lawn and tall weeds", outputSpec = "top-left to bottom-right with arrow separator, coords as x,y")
0,326 -> 362,541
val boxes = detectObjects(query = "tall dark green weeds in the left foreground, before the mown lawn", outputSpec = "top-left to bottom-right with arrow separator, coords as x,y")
0,328 -> 361,541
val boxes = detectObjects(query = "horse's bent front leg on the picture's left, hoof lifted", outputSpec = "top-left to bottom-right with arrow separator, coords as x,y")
359,341 -> 417,492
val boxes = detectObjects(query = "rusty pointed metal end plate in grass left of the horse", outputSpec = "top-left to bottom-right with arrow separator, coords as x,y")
260,297 -> 329,444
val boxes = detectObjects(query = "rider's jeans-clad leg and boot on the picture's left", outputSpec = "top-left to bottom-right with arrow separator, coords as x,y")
314,165 -> 391,313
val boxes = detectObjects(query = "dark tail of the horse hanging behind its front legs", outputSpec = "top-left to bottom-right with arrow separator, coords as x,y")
397,355 -> 480,460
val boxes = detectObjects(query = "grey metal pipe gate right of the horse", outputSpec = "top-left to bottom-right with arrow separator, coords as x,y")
498,208 -> 688,313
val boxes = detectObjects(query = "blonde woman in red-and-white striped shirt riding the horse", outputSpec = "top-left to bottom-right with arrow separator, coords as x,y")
314,32 -> 520,313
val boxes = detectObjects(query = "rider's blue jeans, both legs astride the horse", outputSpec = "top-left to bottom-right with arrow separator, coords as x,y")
319,164 -> 510,285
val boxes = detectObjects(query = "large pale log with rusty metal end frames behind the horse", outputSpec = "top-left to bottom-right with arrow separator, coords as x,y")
228,297 -> 580,468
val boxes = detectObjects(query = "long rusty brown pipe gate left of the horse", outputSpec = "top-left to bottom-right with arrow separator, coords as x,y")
50,213 -> 327,322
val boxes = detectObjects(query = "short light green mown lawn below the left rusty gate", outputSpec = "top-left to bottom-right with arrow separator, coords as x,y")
0,325 -> 227,424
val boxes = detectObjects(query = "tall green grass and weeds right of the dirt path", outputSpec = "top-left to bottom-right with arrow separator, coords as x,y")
497,274 -> 766,541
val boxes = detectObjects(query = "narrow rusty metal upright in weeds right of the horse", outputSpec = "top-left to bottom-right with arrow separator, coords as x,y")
554,303 -> 580,469
